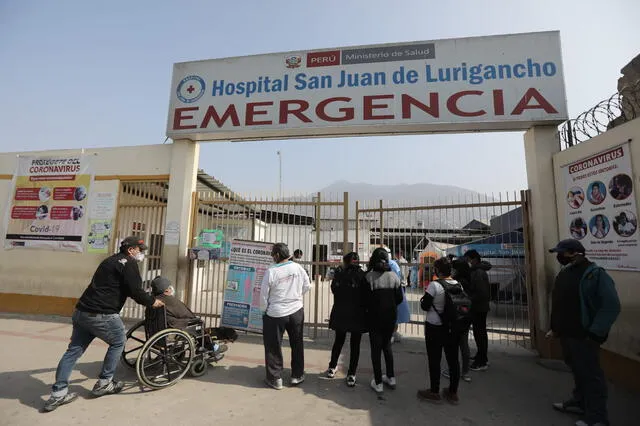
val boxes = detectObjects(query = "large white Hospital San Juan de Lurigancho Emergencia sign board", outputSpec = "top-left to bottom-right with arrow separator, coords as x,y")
167,31 -> 567,141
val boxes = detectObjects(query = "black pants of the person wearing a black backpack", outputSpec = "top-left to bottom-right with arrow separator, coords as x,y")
424,322 -> 460,393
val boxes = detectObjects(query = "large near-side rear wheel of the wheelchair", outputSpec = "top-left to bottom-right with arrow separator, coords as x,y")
136,328 -> 195,389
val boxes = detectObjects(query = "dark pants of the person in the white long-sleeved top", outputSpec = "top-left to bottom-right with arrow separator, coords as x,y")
262,308 -> 304,380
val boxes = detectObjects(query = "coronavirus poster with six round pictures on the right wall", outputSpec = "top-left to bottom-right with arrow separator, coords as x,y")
561,143 -> 640,271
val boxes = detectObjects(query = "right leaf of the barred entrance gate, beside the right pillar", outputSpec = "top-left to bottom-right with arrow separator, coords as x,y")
356,191 -> 533,346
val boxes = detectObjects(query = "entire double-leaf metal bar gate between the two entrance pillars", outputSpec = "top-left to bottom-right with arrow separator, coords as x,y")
186,185 -> 532,345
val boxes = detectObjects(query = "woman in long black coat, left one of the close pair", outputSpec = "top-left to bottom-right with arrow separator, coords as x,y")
325,252 -> 367,387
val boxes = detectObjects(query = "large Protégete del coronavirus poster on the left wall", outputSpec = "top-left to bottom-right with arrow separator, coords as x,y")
5,154 -> 93,252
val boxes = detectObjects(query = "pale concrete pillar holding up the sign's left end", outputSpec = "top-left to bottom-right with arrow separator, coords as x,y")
161,139 -> 200,300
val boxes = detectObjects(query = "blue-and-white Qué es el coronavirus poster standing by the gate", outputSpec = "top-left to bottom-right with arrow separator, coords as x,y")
222,240 -> 273,332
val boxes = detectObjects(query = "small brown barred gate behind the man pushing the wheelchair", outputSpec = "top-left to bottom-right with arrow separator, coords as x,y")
113,181 -> 169,319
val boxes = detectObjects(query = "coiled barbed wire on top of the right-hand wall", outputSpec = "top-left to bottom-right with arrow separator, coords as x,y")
558,81 -> 640,150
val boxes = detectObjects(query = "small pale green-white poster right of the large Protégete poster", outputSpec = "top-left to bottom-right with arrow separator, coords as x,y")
87,192 -> 117,254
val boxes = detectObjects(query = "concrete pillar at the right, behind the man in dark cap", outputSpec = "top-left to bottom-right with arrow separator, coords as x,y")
524,126 -> 560,355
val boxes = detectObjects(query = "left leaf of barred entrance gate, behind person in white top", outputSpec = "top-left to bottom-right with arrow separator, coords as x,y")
186,188 -> 355,337
